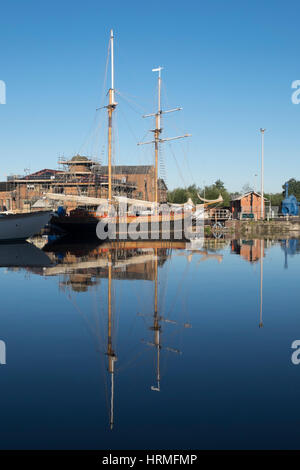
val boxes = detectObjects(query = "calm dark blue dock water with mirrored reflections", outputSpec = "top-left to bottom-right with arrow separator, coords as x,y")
0,240 -> 300,449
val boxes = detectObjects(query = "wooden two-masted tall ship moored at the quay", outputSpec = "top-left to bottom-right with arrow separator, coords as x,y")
47,30 -> 220,240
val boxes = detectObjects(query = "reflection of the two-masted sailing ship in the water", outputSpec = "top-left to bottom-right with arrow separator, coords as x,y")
39,240 -> 222,430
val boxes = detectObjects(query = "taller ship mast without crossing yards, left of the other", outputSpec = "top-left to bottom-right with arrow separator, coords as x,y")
107,30 -> 117,203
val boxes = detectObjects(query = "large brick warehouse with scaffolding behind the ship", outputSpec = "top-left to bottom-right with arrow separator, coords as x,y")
0,155 -> 167,210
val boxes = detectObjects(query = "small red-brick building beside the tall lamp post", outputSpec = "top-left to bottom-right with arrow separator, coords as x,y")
230,191 -> 265,220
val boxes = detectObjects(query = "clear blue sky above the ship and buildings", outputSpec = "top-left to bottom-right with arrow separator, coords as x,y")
0,0 -> 300,192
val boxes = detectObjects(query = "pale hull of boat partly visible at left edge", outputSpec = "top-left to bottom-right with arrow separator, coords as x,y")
0,211 -> 52,242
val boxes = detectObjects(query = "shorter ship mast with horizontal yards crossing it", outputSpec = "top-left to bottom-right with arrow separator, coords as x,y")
138,66 -> 191,211
